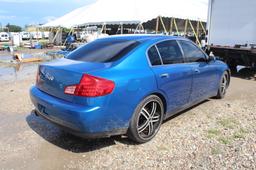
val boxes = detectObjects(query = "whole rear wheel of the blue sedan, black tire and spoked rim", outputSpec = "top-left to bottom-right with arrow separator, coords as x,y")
128,95 -> 164,143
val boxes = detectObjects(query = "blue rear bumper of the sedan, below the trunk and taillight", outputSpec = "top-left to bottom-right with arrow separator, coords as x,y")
30,86 -> 127,138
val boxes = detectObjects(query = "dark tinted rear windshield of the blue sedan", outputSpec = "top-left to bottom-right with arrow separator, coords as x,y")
66,39 -> 140,63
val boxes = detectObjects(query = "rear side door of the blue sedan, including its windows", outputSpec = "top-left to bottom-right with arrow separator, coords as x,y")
148,40 -> 192,114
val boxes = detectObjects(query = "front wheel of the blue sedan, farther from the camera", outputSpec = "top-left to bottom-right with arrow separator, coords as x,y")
215,71 -> 230,99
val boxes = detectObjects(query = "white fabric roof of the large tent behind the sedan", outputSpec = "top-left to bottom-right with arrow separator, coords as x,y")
43,0 -> 208,28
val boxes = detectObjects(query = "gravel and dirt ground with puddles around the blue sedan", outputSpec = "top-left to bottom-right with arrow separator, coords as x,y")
0,65 -> 256,170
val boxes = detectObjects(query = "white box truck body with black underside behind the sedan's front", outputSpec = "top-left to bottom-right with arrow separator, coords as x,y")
207,0 -> 256,71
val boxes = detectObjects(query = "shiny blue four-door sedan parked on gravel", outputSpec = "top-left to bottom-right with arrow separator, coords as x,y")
30,35 -> 230,143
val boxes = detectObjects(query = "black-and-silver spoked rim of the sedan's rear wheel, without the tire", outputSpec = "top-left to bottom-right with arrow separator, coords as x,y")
137,101 -> 162,139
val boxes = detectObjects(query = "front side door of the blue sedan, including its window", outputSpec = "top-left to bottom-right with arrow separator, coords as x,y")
178,40 -> 218,102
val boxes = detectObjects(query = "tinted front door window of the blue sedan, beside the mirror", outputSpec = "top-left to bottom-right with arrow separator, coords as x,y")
180,41 -> 205,62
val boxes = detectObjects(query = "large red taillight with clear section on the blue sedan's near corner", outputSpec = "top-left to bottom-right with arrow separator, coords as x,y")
64,74 -> 115,97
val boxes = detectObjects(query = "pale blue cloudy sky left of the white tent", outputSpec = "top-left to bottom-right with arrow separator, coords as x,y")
0,0 -> 96,27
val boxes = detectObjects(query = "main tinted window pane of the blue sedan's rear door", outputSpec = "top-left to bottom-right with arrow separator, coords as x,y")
157,41 -> 184,64
